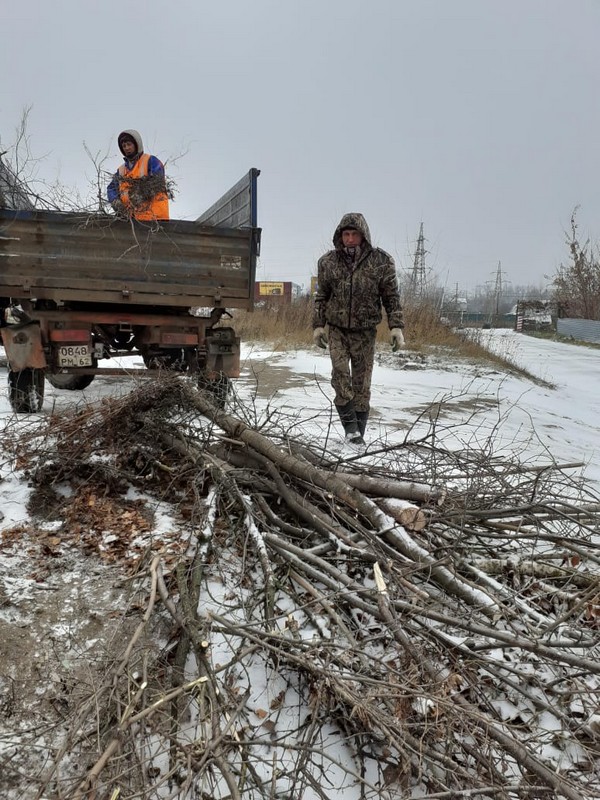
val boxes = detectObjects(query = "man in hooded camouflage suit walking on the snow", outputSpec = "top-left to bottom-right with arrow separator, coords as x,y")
313,213 -> 404,444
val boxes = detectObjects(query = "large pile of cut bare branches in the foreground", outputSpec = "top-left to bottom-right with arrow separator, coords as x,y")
0,378 -> 600,800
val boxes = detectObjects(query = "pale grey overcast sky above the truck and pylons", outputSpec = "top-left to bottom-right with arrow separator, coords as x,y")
0,0 -> 600,293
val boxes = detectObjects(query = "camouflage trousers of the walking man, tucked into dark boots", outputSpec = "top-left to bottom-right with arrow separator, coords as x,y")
329,325 -> 377,411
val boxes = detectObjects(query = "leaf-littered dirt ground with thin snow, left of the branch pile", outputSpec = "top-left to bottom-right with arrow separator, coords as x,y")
0,432 -> 185,800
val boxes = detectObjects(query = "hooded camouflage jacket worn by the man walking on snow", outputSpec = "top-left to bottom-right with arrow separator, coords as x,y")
313,213 -> 404,330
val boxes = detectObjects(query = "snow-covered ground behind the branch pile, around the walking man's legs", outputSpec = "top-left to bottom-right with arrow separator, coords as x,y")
238,330 -> 600,485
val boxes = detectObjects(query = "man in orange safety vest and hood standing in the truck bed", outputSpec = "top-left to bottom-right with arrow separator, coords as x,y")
107,130 -> 169,222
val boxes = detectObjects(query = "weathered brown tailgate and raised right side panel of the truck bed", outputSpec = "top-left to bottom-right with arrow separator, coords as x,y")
0,170 -> 260,309
